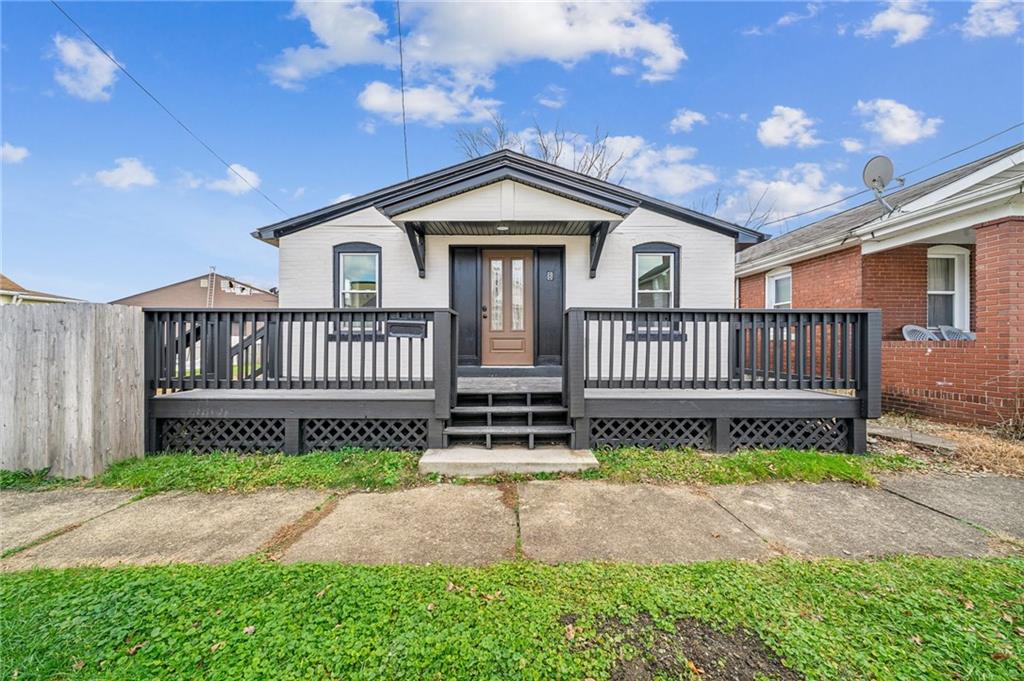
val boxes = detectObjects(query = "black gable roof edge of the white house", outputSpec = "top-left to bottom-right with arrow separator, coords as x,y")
252,150 -> 765,244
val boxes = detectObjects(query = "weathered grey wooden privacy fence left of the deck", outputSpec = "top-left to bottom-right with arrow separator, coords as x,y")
0,303 -> 145,477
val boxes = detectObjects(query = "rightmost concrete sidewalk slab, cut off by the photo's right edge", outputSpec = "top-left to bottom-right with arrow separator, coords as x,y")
882,473 -> 1024,539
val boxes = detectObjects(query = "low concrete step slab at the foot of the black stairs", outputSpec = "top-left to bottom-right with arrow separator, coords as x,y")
420,446 -> 598,477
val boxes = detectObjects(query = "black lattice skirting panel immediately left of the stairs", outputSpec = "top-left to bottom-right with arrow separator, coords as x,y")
302,419 -> 427,452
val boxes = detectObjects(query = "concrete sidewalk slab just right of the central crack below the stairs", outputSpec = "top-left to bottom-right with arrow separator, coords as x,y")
519,480 -> 772,563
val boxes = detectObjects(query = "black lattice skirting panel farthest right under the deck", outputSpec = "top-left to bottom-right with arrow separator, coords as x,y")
729,419 -> 850,452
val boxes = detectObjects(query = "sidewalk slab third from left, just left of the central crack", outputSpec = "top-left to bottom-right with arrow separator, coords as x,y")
282,484 -> 516,565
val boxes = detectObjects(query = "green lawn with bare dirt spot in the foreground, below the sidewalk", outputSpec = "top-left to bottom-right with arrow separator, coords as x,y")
0,557 -> 1024,679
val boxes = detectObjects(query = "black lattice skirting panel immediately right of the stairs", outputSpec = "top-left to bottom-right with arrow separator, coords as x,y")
590,418 -> 714,450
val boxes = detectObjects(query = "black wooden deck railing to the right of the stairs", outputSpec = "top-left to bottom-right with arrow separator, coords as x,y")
564,308 -> 881,416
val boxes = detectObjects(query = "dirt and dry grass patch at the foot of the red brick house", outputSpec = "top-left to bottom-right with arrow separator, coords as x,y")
874,414 -> 1024,477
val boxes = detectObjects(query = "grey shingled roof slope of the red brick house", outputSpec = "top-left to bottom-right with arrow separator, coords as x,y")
736,142 -> 1024,268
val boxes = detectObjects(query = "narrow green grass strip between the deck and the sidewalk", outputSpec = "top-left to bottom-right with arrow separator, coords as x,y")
0,448 -> 920,495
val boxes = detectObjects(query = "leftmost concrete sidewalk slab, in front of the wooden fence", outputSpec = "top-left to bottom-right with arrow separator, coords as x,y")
0,487 -> 135,551
